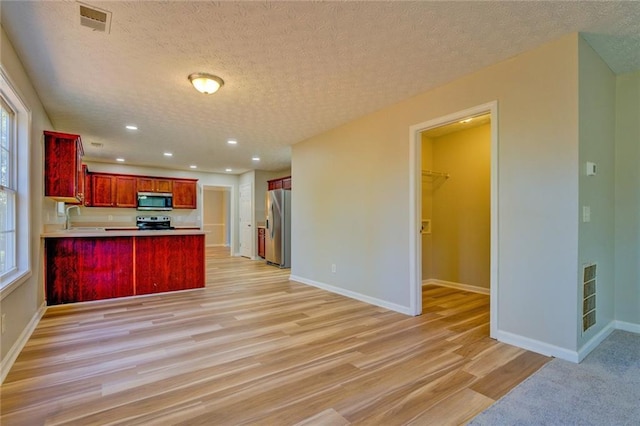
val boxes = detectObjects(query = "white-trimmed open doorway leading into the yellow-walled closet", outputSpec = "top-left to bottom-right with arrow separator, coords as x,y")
410,102 -> 499,337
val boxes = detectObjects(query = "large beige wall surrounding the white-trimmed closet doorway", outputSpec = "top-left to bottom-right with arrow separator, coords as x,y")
292,34 -> 579,357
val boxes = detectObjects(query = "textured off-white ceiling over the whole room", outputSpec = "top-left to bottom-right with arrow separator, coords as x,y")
0,0 -> 640,173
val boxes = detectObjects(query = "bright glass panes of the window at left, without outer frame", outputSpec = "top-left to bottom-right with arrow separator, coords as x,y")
0,98 -> 17,281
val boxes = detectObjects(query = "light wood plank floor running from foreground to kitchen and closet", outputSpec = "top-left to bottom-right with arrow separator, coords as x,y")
0,248 -> 549,426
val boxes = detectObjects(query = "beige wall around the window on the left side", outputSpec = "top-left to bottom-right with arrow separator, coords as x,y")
0,25 -> 55,366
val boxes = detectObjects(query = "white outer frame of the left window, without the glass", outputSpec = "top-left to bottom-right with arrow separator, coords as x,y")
0,66 -> 32,300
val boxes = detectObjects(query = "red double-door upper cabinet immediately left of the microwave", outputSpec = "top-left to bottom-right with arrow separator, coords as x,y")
89,173 -> 137,207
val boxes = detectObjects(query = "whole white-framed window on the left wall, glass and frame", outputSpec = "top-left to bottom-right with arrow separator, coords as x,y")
0,67 -> 31,299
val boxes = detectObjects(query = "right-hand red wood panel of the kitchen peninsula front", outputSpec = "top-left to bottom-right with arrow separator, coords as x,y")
135,235 -> 204,294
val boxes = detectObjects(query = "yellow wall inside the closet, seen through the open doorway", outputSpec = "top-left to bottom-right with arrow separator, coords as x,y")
422,124 -> 491,289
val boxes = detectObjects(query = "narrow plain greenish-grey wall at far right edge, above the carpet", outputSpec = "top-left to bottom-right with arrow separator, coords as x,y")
615,72 -> 640,326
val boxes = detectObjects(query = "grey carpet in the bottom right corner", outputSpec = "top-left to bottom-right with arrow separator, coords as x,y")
469,330 -> 640,426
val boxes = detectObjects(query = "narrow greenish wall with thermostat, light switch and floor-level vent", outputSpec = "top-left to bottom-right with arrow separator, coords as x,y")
576,37 -> 616,356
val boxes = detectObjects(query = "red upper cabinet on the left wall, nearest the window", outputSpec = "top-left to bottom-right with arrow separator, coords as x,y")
44,131 -> 84,203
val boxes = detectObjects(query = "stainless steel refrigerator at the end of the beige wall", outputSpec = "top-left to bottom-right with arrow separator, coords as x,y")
264,189 -> 291,268
